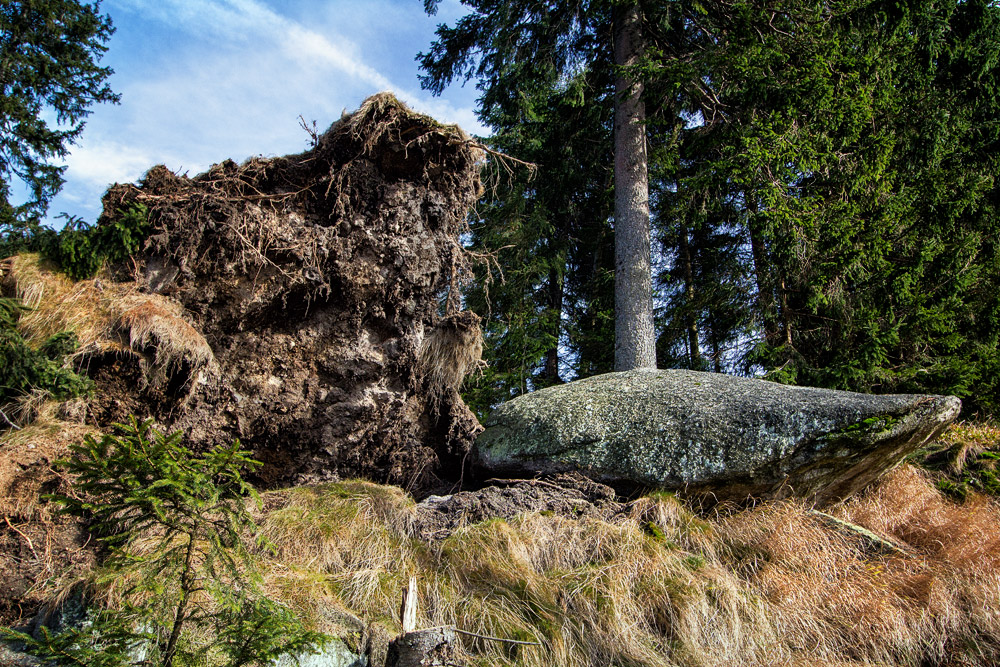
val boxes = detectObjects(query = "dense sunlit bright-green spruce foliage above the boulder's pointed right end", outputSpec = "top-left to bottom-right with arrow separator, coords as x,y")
706,2 -> 1000,411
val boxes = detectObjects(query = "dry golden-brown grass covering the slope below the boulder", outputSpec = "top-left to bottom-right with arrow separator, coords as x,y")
256,468 -> 1000,667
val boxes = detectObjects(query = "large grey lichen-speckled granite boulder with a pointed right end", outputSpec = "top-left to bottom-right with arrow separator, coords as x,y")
475,370 -> 961,504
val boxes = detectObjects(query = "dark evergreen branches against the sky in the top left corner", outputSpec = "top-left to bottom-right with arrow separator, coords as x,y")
0,0 -> 119,228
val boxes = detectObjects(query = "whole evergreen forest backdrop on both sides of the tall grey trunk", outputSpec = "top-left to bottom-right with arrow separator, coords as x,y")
419,0 -> 1000,413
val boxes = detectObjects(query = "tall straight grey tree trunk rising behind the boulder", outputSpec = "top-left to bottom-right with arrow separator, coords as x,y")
614,5 -> 656,371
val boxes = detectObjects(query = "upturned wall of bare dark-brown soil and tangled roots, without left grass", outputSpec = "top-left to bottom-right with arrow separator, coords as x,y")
95,94 -> 481,490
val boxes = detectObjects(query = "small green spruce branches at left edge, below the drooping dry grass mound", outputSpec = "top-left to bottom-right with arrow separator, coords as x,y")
0,297 -> 92,410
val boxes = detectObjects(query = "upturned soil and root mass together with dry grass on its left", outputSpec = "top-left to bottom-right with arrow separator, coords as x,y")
0,94 -> 483,628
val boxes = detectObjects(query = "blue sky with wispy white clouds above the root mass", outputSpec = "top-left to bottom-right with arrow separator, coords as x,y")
41,0 -> 484,224
